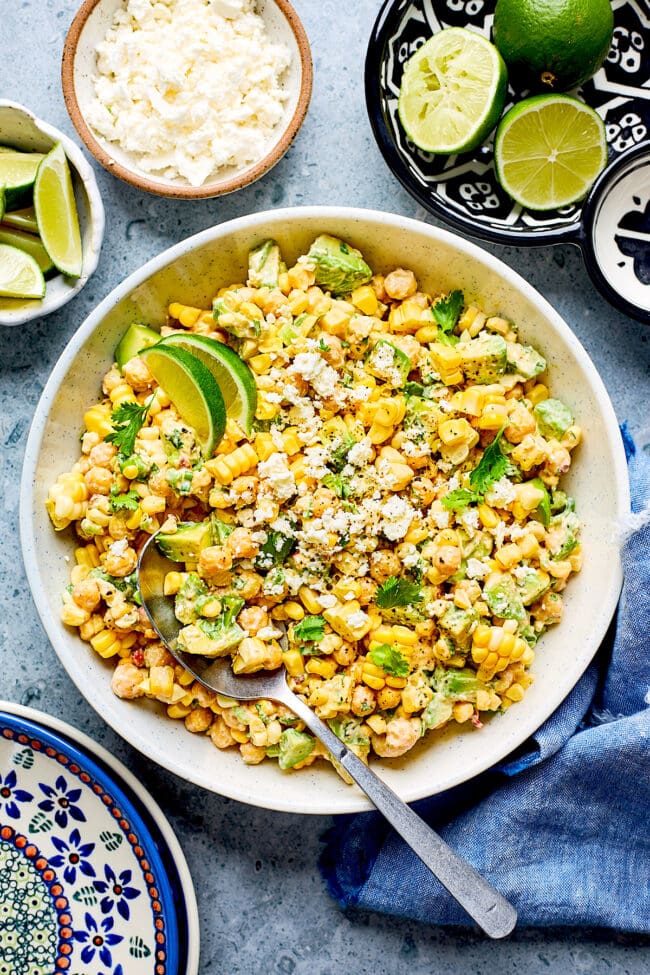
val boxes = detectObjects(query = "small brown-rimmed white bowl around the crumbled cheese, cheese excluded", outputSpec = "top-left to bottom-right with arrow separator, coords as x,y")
61,0 -> 313,200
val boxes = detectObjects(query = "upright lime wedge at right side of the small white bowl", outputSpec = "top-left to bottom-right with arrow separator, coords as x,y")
34,142 -> 82,278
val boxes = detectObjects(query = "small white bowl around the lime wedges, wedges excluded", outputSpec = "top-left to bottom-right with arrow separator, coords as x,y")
0,100 -> 104,325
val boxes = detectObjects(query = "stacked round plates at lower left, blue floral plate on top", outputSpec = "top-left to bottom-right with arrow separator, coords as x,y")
0,702 -> 199,975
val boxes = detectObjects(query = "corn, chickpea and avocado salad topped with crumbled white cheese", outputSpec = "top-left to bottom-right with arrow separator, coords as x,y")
47,235 -> 582,769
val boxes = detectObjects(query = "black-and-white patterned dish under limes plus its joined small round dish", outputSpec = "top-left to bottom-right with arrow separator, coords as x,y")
365,0 -> 650,322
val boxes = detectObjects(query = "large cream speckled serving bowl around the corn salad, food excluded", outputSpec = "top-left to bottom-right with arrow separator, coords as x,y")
21,207 -> 629,813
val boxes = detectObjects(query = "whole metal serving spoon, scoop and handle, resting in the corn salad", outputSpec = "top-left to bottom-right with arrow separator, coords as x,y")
137,535 -> 517,938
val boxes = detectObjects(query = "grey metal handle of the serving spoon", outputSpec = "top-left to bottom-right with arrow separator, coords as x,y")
283,688 -> 517,938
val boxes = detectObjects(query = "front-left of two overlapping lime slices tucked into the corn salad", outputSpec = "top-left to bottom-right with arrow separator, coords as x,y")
140,343 -> 226,457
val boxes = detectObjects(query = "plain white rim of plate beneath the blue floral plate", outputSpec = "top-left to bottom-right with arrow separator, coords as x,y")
0,700 -> 200,975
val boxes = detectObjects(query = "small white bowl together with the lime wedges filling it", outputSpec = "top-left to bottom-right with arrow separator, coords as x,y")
0,100 -> 104,325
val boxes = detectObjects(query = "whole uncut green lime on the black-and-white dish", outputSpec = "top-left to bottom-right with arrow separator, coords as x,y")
494,0 -> 614,91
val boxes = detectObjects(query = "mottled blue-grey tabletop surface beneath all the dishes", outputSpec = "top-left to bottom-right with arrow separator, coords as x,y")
0,0 -> 650,975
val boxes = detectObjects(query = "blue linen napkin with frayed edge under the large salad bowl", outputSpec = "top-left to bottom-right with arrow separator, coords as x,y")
320,427 -> 650,933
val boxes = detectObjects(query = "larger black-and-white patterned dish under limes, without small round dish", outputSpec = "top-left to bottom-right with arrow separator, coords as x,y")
365,0 -> 650,245
